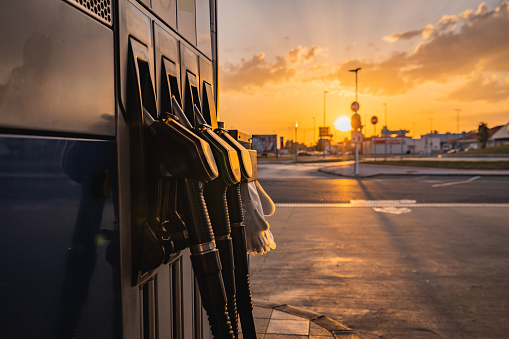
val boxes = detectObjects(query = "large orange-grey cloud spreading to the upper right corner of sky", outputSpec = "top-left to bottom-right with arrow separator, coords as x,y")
325,1 -> 509,101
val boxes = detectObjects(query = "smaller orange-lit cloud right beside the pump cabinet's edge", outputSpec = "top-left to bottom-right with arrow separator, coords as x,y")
219,45 -> 321,91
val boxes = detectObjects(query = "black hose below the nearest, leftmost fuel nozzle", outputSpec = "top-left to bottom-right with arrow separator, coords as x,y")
184,178 -> 234,339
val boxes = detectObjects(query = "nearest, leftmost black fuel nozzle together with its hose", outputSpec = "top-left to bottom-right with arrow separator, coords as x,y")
144,105 -> 233,338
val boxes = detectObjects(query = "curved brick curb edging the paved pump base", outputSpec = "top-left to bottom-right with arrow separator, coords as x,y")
253,300 -> 355,335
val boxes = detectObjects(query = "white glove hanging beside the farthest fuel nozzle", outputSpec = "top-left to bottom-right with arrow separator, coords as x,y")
240,181 -> 276,254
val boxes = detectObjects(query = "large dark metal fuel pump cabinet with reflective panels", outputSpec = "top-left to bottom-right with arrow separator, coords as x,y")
0,0 -> 256,339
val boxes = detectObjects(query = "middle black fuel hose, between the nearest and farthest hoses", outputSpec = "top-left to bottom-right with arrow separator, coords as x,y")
203,178 -> 239,338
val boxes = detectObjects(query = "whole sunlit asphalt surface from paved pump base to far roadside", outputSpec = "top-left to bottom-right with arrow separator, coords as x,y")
251,165 -> 509,339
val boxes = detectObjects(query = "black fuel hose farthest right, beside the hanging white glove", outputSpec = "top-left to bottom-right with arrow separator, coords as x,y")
226,183 -> 256,339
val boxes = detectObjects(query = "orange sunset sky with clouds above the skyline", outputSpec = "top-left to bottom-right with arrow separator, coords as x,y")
218,0 -> 509,144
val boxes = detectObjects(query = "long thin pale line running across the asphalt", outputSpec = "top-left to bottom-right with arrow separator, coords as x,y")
276,200 -> 509,208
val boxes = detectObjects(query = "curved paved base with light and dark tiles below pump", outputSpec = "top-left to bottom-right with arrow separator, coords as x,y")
239,300 -> 359,339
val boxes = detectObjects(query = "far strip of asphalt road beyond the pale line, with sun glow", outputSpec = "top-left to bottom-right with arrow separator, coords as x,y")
258,164 -> 509,203
